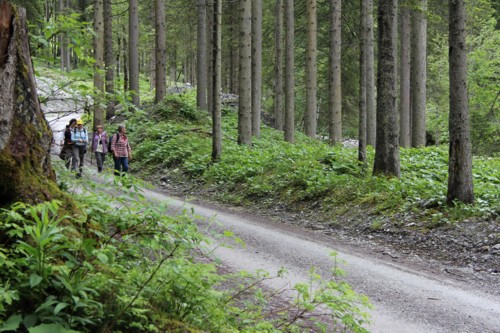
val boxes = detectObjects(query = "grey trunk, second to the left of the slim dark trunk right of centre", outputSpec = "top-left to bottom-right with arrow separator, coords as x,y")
304,0 -> 318,138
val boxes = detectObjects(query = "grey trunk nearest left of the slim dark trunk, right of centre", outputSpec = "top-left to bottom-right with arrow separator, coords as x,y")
328,0 -> 342,144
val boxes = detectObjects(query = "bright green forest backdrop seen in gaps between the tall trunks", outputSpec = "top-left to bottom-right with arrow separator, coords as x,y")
9,0 -> 500,155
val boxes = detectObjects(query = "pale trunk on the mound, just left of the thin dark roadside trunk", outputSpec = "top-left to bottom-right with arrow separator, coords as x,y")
196,0 -> 207,110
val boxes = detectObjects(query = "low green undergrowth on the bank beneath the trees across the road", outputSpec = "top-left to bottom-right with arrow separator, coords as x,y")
128,92 -> 500,227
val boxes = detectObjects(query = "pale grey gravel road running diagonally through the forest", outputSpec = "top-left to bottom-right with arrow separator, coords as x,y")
119,182 -> 500,333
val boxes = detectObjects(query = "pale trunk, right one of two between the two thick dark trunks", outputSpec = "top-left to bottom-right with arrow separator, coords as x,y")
411,0 -> 427,147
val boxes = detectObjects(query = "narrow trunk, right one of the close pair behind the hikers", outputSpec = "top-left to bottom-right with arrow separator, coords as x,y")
103,0 -> 115,115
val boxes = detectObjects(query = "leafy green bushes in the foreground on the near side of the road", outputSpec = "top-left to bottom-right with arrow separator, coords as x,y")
0,163 -> 369,333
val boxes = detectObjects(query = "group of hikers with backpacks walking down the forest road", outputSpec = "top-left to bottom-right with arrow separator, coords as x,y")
59,119 -> 132,178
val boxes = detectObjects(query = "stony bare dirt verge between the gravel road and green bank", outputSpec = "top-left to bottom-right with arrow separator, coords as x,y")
148,170 -> 500,295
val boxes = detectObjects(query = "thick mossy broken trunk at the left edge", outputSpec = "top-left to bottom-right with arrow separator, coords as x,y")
0,2 -> 64,207
